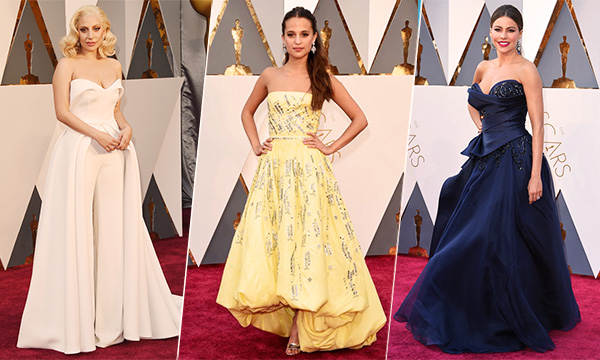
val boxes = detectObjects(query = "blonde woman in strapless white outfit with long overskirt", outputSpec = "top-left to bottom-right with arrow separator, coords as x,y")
17,6 -> 181,354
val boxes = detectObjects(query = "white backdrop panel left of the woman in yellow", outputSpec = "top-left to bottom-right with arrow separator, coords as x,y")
189,75 -> 266,263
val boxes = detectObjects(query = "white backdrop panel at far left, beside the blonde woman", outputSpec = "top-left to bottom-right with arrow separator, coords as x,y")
0,85 -> 56,266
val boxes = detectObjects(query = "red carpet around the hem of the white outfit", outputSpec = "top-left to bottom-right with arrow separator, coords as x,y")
0,229 -> 189,359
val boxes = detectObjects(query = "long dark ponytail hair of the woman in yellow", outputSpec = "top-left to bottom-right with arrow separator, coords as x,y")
281,6 -> 333,110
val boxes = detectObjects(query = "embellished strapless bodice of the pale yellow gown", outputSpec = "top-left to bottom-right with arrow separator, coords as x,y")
267,91 -> 321,139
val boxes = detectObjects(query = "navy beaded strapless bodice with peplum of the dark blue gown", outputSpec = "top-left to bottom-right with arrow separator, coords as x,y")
462,80 -> 529,157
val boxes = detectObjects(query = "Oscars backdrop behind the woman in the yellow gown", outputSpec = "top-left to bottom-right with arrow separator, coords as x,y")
189,0 -> 419,265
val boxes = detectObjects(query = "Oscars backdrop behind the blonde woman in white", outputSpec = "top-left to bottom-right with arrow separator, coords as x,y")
0,0 -> 182,268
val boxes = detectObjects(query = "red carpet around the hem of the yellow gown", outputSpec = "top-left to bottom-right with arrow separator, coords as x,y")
179,255 -> 394,360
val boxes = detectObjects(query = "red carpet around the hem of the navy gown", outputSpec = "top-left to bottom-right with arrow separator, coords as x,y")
388,255 -> 600,360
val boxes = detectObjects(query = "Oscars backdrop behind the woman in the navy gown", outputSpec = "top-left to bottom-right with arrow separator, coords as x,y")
398,0 -> 600,275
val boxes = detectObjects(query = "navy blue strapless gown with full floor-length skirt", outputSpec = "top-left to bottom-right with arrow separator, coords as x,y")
394,80 -> 581,353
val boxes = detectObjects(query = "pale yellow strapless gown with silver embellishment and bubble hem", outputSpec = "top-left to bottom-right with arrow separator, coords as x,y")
217,91 -> 386,351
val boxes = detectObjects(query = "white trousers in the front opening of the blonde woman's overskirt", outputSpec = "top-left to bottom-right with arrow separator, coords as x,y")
85,142 -> 125,347
